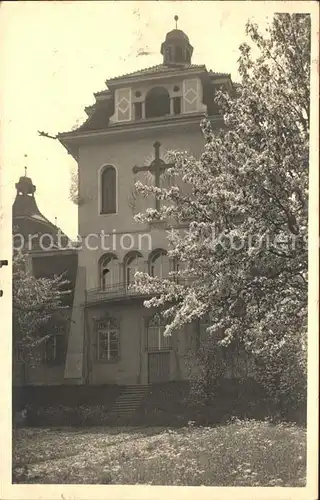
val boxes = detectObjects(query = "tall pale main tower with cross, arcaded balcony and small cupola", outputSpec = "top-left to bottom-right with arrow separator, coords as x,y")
58,17 -> 233,385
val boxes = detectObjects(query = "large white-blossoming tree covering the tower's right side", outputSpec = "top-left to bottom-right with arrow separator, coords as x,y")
136,13 -> 310,408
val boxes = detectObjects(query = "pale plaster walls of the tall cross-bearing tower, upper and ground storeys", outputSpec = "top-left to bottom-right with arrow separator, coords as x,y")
70,120 -> 208,385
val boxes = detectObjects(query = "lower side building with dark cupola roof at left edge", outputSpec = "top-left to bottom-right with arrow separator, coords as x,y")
12,167 -> 78,386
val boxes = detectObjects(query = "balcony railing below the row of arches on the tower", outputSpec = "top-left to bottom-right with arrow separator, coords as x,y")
86,278 -> 190,304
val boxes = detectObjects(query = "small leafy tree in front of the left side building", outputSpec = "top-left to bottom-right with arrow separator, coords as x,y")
12,253 -> 70,363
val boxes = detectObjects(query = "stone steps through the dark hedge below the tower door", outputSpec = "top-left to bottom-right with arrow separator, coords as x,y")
108,385 -> 150,421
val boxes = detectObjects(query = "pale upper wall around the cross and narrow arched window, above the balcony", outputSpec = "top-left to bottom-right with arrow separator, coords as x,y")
79,125 -> 203,289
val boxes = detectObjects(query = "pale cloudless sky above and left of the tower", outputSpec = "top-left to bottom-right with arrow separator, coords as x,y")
0,1 -> 277,237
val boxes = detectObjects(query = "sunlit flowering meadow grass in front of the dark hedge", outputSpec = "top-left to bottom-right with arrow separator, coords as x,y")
13,420 -> 306,487
